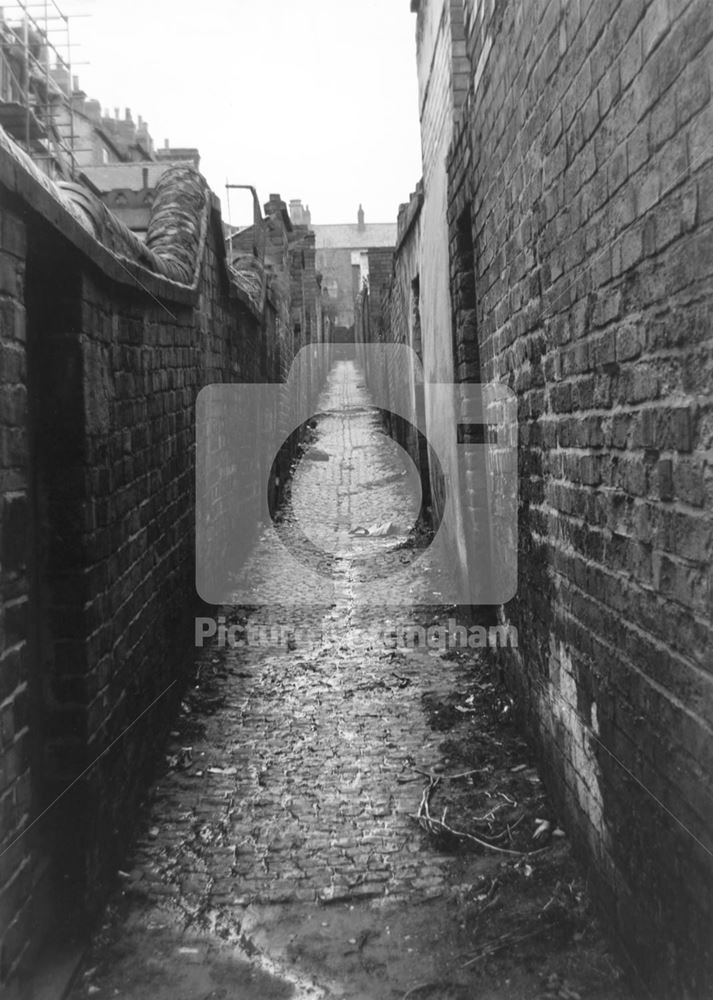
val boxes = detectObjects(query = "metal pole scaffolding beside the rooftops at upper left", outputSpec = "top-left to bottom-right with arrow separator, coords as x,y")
0,0 -> 81,180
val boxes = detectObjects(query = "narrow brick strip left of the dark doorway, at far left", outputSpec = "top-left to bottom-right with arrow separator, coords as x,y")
0,191 -> 47,982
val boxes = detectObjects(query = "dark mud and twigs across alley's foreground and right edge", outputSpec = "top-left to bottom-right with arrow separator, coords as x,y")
73,640 -> 632,1000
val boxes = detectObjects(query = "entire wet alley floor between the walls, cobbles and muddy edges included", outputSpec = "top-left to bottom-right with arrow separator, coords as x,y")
71,362 -> 631,1000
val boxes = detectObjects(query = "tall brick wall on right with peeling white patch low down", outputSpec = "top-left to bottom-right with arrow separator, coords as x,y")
444,0 -> 713,998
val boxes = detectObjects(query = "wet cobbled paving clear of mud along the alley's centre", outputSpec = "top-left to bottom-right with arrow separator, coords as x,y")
121,362 -> 455,913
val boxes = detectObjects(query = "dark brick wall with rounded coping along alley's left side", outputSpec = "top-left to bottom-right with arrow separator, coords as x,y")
0,135 -> 292,983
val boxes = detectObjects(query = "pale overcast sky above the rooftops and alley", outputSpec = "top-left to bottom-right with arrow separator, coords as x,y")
58,0 -> 421,223
